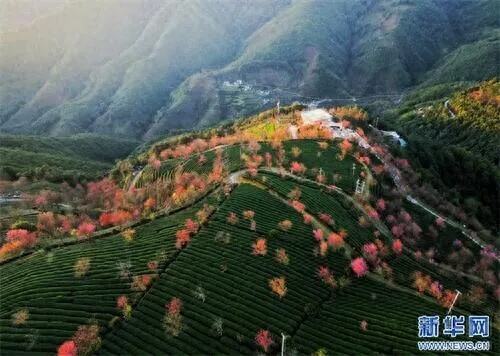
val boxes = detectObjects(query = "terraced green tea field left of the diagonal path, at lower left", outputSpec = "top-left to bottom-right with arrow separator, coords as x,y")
0,196 -> 217,354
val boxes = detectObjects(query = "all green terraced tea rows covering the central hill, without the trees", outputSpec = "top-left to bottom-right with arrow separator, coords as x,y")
0,140 -> 498,355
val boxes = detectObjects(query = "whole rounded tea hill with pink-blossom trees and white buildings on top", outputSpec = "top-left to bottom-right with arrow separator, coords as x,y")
0,106 -> 499,355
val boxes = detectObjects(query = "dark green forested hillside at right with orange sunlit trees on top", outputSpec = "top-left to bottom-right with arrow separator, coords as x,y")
387,79 -> 500,232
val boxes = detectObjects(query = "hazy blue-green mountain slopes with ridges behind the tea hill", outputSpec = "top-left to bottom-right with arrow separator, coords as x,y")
0,0 -> 499,139
